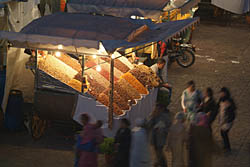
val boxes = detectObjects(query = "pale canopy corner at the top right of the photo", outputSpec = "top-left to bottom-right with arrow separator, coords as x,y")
212,0 -> 250,14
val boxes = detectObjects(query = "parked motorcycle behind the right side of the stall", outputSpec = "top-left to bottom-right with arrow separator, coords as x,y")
166,38 -> 195,68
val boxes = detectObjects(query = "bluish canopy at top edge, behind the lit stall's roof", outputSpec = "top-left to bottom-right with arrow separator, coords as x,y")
67,0 -> 198,20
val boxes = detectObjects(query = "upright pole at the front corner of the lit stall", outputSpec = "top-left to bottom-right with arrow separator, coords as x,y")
109,54 -> 114,129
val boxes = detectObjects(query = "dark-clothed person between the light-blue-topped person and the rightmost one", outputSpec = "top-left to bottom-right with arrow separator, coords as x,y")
202,87 -> 218,130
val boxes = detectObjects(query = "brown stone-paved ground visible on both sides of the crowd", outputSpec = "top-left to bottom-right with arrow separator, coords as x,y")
0,24 -> 250,167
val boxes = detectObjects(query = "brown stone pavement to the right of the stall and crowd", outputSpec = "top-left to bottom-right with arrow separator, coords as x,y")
169,25 -> 250,167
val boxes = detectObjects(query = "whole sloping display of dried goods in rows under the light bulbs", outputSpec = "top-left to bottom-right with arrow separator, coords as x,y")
38,51 -> 160,115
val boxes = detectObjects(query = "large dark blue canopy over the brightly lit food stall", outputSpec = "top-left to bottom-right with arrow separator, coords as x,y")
0,13 -> 199,54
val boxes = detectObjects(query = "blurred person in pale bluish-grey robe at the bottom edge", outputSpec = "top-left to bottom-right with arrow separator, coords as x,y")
130,119 -> 152,167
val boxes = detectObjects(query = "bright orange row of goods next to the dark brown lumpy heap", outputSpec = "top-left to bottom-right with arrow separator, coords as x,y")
121,72 -> 148,94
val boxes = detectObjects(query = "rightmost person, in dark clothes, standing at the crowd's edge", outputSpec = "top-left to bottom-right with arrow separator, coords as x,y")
218,87 -> 236,152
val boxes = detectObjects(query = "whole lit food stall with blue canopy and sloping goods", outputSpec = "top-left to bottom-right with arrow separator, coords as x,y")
0,13 -> 199,137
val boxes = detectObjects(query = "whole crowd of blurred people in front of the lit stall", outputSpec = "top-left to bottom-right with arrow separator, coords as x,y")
75,81 -> 236,167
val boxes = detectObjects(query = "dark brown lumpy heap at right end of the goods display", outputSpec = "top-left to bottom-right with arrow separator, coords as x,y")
129,65 -> 160,87
